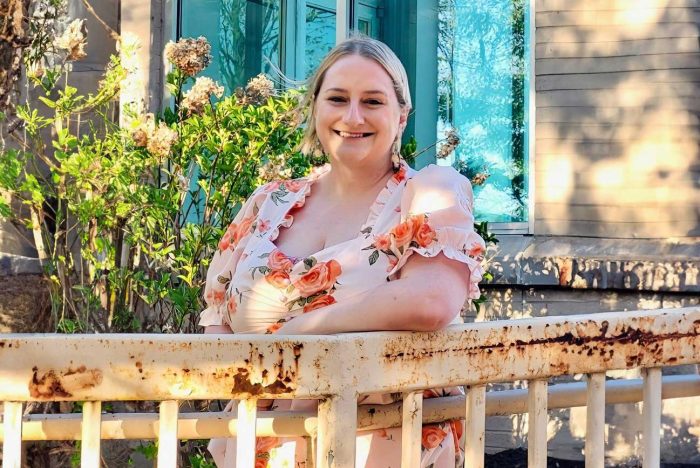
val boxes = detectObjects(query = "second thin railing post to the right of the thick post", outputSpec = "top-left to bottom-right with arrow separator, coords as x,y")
464,385 -> 486,468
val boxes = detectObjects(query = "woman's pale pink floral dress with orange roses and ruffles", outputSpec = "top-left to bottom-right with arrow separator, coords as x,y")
199,164 -> 484,468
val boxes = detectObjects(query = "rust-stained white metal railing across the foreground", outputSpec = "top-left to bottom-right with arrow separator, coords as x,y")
0,307 -> 700,468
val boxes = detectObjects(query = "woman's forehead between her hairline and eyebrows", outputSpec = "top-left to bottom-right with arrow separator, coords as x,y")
321,55 -> 394,94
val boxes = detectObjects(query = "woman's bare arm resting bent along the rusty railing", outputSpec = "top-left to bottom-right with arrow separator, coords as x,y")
276,254 -> 469,335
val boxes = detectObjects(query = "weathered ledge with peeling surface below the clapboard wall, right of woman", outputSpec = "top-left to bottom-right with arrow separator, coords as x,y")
487,235 -> 700,292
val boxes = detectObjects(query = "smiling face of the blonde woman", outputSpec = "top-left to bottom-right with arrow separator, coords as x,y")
315,55 -> 406,170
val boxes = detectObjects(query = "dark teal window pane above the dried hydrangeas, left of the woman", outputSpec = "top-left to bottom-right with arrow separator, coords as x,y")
181,0 -> 282,93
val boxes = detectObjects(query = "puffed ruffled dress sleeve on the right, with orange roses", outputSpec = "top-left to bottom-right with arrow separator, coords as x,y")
389,165 -> 485,299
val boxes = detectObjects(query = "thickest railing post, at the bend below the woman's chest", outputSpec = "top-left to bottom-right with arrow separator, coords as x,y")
316,393 -> 357,468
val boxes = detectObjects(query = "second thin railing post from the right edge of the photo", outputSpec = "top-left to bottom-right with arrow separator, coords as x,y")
585,372 -> 605,468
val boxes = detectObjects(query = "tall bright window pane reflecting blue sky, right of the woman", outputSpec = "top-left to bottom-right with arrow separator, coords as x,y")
438,0 -> 529,222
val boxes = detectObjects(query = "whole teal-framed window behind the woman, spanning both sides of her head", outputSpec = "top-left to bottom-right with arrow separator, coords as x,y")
179,0 -> 532,232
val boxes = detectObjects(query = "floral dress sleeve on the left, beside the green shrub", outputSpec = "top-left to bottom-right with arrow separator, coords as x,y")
199,186 -> 266,327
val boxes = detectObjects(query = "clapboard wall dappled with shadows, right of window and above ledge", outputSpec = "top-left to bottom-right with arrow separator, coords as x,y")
533,0 -> 700,238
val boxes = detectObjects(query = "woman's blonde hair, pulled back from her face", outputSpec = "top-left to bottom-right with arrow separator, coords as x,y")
299,33 -> 411,155
